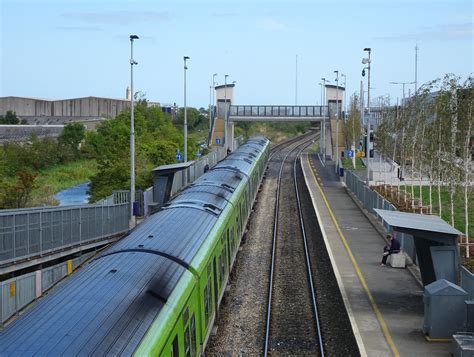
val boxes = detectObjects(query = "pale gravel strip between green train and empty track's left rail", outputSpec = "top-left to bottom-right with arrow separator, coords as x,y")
206,152 -> 278,356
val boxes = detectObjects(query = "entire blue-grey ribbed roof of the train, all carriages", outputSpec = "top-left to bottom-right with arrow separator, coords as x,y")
0,139 -> 267,355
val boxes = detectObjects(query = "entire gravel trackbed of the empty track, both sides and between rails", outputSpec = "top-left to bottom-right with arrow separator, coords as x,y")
206,135 -> 358,356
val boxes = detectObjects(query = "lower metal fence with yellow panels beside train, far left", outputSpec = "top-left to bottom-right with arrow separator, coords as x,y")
0,252 -> 94,325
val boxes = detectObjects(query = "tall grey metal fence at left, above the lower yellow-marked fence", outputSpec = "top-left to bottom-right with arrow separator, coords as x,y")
0,203 -> 129,266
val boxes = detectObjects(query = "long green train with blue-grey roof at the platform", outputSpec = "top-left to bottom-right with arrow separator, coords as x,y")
0,137 -> 270,357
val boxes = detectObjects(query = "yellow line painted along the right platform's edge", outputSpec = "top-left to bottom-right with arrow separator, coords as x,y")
311,155 -> 400,357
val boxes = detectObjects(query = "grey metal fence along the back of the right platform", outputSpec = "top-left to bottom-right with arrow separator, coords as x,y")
344,170 -> 416,262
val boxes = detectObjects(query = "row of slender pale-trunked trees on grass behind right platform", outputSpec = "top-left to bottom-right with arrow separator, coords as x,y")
366,74 -> 474,238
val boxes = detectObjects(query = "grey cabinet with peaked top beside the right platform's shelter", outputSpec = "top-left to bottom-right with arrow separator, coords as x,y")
423,279 -> 468,339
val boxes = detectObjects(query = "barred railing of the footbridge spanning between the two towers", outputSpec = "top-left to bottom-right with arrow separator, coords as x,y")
229,105 -> 328,118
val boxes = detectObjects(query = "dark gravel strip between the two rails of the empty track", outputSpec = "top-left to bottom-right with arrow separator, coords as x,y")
269,152 -> 318,355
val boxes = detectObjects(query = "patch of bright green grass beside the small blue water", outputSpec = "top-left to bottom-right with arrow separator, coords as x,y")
30,159 -> 97,206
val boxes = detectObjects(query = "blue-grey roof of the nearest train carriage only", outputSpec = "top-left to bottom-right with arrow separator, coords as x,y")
0,253 -> 191,356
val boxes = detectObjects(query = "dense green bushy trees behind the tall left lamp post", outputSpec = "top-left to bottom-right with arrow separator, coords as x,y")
83,100 -> 197,201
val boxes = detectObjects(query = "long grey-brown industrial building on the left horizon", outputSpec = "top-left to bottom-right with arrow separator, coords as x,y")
0,94 -> 160,129
